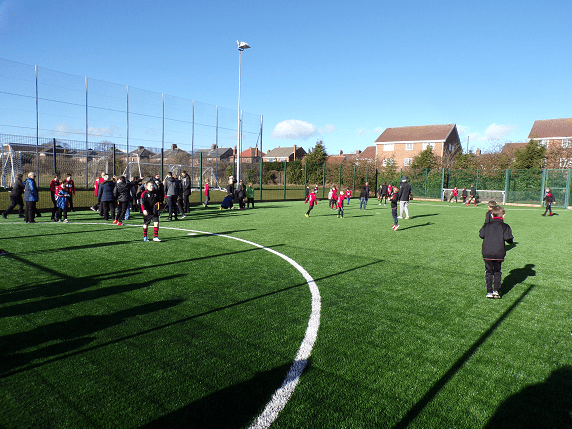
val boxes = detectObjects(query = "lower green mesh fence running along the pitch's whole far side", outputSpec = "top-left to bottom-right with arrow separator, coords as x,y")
0,134 -> 571,208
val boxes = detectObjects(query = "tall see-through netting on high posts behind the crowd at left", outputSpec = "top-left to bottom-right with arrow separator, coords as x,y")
0,59 -> 262,188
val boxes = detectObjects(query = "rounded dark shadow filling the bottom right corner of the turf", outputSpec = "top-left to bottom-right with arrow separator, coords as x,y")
485,365 -> 572,429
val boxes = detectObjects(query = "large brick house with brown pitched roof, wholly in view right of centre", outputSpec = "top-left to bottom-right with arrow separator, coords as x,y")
375,124 -> 462,168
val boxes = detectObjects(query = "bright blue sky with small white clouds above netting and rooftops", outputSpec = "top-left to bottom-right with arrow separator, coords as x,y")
0,0 -> 572,154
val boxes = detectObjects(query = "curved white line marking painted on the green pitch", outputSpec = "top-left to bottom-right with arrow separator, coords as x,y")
52,222 -> 322,429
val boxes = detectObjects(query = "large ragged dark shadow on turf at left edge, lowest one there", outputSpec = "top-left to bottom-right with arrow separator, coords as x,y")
0,298 -> 184,378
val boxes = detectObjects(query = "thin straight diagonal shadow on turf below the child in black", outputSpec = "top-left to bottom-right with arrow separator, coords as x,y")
393,285 -> 535,429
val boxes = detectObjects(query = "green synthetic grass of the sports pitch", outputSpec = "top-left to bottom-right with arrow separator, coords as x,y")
0,199 -> 572,428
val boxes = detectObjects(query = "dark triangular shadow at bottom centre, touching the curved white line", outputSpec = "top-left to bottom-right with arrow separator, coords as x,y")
140,361 -> 311,429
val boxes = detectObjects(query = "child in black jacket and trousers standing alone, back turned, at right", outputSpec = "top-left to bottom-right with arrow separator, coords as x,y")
479,206 -> 514,298
